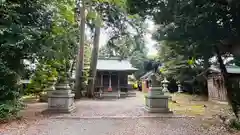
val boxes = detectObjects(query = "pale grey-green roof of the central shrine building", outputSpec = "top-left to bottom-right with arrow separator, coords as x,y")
97,58 -> 137,71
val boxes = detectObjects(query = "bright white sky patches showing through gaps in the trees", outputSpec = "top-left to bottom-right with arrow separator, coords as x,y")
99,20 -> 157,55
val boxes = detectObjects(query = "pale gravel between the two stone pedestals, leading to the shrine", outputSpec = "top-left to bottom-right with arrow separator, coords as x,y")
56,92 -> 176,117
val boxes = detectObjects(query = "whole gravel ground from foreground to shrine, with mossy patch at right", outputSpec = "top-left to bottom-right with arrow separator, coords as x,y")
0,93 -> 234,135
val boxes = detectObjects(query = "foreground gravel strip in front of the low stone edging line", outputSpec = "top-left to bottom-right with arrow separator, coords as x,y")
3,118 -> 229,135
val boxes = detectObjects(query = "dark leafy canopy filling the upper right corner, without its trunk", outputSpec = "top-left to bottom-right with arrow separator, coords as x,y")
128,0 -> 239,56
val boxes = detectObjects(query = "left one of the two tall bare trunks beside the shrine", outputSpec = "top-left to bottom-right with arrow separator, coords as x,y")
75,0 -> 86,98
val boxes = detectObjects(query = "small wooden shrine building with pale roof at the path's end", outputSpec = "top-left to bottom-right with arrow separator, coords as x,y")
95,58 -> 137,96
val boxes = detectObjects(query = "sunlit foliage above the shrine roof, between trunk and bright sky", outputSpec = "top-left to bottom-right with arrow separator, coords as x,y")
99,13 -> 148,78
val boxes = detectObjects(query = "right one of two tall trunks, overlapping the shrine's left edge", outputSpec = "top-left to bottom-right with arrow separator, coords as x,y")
87,26 -> 100,98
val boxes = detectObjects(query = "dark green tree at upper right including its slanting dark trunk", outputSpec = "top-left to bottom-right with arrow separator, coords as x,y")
128,0 -> 240,116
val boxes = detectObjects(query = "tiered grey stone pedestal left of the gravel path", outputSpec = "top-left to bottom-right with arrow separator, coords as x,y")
48,83 -> 75,113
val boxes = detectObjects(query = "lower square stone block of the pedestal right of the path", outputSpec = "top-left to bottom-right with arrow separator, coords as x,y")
145,95 -> 172,113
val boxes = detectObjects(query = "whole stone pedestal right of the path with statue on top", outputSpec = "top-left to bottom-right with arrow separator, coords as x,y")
145,75 -> 171,113
